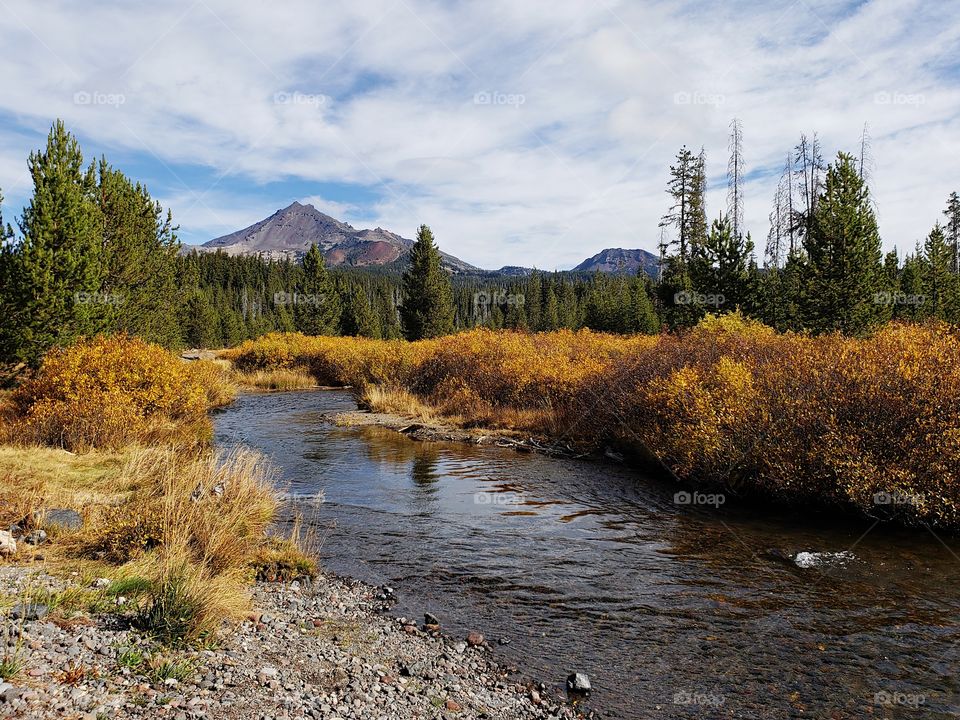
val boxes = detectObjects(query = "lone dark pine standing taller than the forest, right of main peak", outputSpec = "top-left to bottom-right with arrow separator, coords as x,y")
400,225 -> 453,340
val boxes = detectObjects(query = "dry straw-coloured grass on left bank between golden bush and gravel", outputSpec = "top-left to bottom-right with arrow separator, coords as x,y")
0,447 -> 316,643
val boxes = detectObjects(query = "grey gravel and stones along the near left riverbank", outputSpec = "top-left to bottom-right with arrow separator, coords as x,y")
0,565 -> 575,720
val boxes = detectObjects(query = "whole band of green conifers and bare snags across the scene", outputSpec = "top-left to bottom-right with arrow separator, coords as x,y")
0,120 -> 960,363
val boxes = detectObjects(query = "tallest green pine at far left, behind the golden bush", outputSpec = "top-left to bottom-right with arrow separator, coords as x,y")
4,120 -> 109,363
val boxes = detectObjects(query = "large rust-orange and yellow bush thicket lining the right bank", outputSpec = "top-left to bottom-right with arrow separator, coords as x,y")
569,316 -> 960,526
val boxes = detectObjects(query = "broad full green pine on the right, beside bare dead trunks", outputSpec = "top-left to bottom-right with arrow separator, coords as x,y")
803,153 -> 882,335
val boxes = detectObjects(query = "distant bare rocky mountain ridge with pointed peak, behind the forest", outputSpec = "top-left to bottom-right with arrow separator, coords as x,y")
195,202 -> 659,277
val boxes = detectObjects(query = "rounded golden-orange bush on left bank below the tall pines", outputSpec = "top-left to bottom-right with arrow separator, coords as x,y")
4,335 -> 231,450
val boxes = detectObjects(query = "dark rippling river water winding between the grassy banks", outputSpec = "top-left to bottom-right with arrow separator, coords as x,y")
215,391 -> 960,719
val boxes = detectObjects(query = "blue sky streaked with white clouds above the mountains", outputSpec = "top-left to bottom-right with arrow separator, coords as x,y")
0,0 -> 960,270
